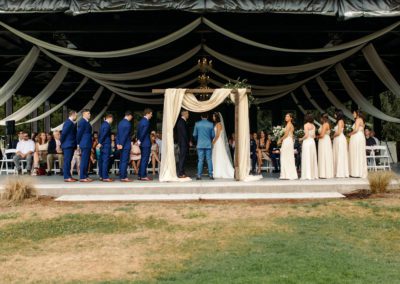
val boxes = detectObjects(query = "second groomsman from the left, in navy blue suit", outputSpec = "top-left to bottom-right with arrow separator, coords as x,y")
76,109 -> 93,182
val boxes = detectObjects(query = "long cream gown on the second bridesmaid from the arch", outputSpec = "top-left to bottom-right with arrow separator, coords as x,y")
301,128 -> 318,179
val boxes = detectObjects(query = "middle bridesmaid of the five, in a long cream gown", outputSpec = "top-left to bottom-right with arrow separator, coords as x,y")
318,113 -> 333,178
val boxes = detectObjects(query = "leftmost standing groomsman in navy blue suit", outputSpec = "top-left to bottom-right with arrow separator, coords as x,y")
61,110 -> 77,182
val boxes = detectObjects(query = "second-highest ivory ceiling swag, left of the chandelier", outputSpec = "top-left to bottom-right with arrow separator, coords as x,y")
40,45 -> 201,81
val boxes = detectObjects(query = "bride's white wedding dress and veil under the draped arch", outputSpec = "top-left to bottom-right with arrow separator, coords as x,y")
212,114 -> 235,179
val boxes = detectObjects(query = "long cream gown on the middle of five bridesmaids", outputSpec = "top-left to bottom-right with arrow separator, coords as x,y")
318,126 -> 333,178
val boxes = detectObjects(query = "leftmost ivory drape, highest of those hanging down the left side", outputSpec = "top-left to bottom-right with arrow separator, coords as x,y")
0,46 -> 40,106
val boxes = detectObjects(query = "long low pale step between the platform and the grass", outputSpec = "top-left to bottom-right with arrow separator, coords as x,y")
56,192 -> 345,202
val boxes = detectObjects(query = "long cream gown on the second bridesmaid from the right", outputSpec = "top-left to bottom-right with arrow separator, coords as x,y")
333,125 -> 349,178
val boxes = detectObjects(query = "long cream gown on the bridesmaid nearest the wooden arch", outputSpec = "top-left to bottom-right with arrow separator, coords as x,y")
280,128 -> 298,179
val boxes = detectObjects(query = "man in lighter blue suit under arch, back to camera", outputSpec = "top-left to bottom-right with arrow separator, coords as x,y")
193,113 -> 215,180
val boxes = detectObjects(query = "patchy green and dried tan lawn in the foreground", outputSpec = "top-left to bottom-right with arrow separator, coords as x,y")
0,194 -> 400,284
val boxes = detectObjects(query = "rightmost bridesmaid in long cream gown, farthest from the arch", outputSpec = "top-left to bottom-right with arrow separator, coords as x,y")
349,110 -> 368,178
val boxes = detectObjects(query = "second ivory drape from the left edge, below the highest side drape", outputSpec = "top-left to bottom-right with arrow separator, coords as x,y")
0,66 -> 68,125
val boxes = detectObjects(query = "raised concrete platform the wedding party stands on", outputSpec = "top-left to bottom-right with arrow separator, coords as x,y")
0,175 -> 376,198
